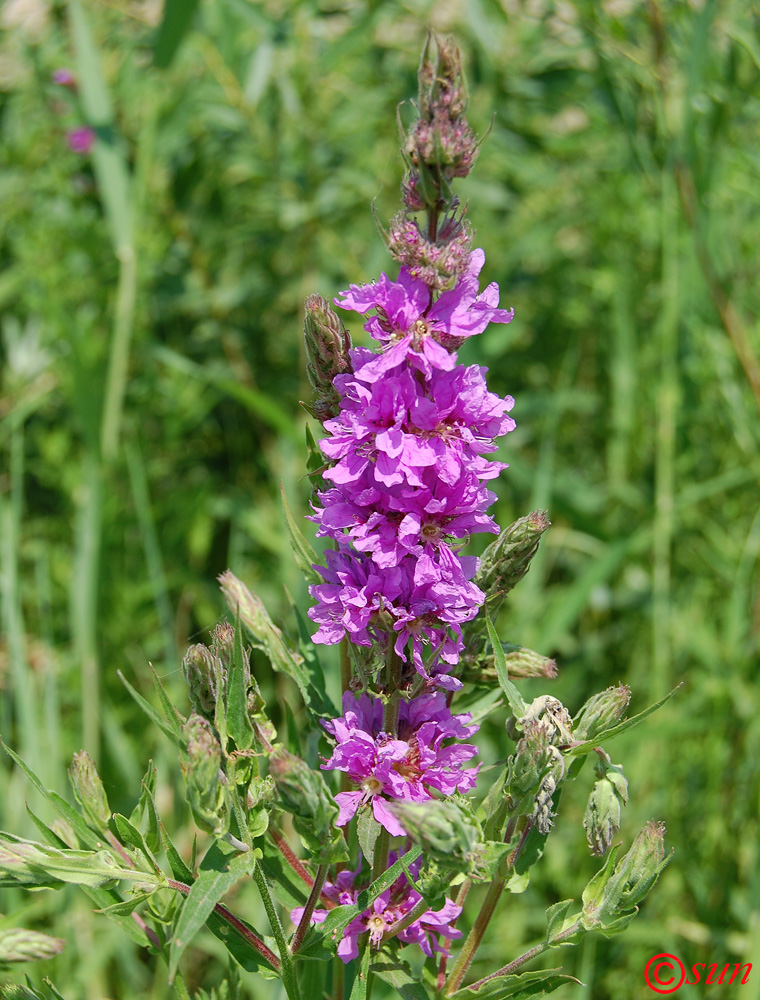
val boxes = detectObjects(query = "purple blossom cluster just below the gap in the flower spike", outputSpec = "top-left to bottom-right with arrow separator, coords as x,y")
322,692 -> 478,836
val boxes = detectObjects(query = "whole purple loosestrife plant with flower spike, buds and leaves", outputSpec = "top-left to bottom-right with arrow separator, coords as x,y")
0,31 -> 669,1000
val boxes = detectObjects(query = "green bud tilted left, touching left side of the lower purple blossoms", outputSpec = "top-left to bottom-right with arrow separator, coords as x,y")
269,749 -> 347,864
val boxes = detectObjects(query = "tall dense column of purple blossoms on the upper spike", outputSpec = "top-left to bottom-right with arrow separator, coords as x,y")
309,250 -> 514,689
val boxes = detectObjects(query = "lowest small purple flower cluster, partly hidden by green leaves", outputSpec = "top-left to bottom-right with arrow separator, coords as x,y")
290,853 -> 462,962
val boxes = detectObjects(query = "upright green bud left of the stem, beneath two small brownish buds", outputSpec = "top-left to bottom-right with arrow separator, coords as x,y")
181,713 -> 230,837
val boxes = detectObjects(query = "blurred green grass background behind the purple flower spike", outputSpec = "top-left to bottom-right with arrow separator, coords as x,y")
0,0 -> 760,1000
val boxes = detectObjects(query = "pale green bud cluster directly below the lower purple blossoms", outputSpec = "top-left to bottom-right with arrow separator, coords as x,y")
387,799 -> 482,868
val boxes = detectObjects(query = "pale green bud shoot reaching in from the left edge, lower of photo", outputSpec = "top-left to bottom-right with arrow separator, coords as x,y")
0,833 -> 166,889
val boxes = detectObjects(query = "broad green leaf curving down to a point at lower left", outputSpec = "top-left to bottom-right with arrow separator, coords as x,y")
169,841 -> 260,980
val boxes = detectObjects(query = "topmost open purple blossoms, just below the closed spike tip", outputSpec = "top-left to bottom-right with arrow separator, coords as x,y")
335,250 -> 514,381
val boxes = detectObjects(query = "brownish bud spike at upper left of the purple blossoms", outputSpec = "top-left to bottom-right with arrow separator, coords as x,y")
304,295 -> 353,423
